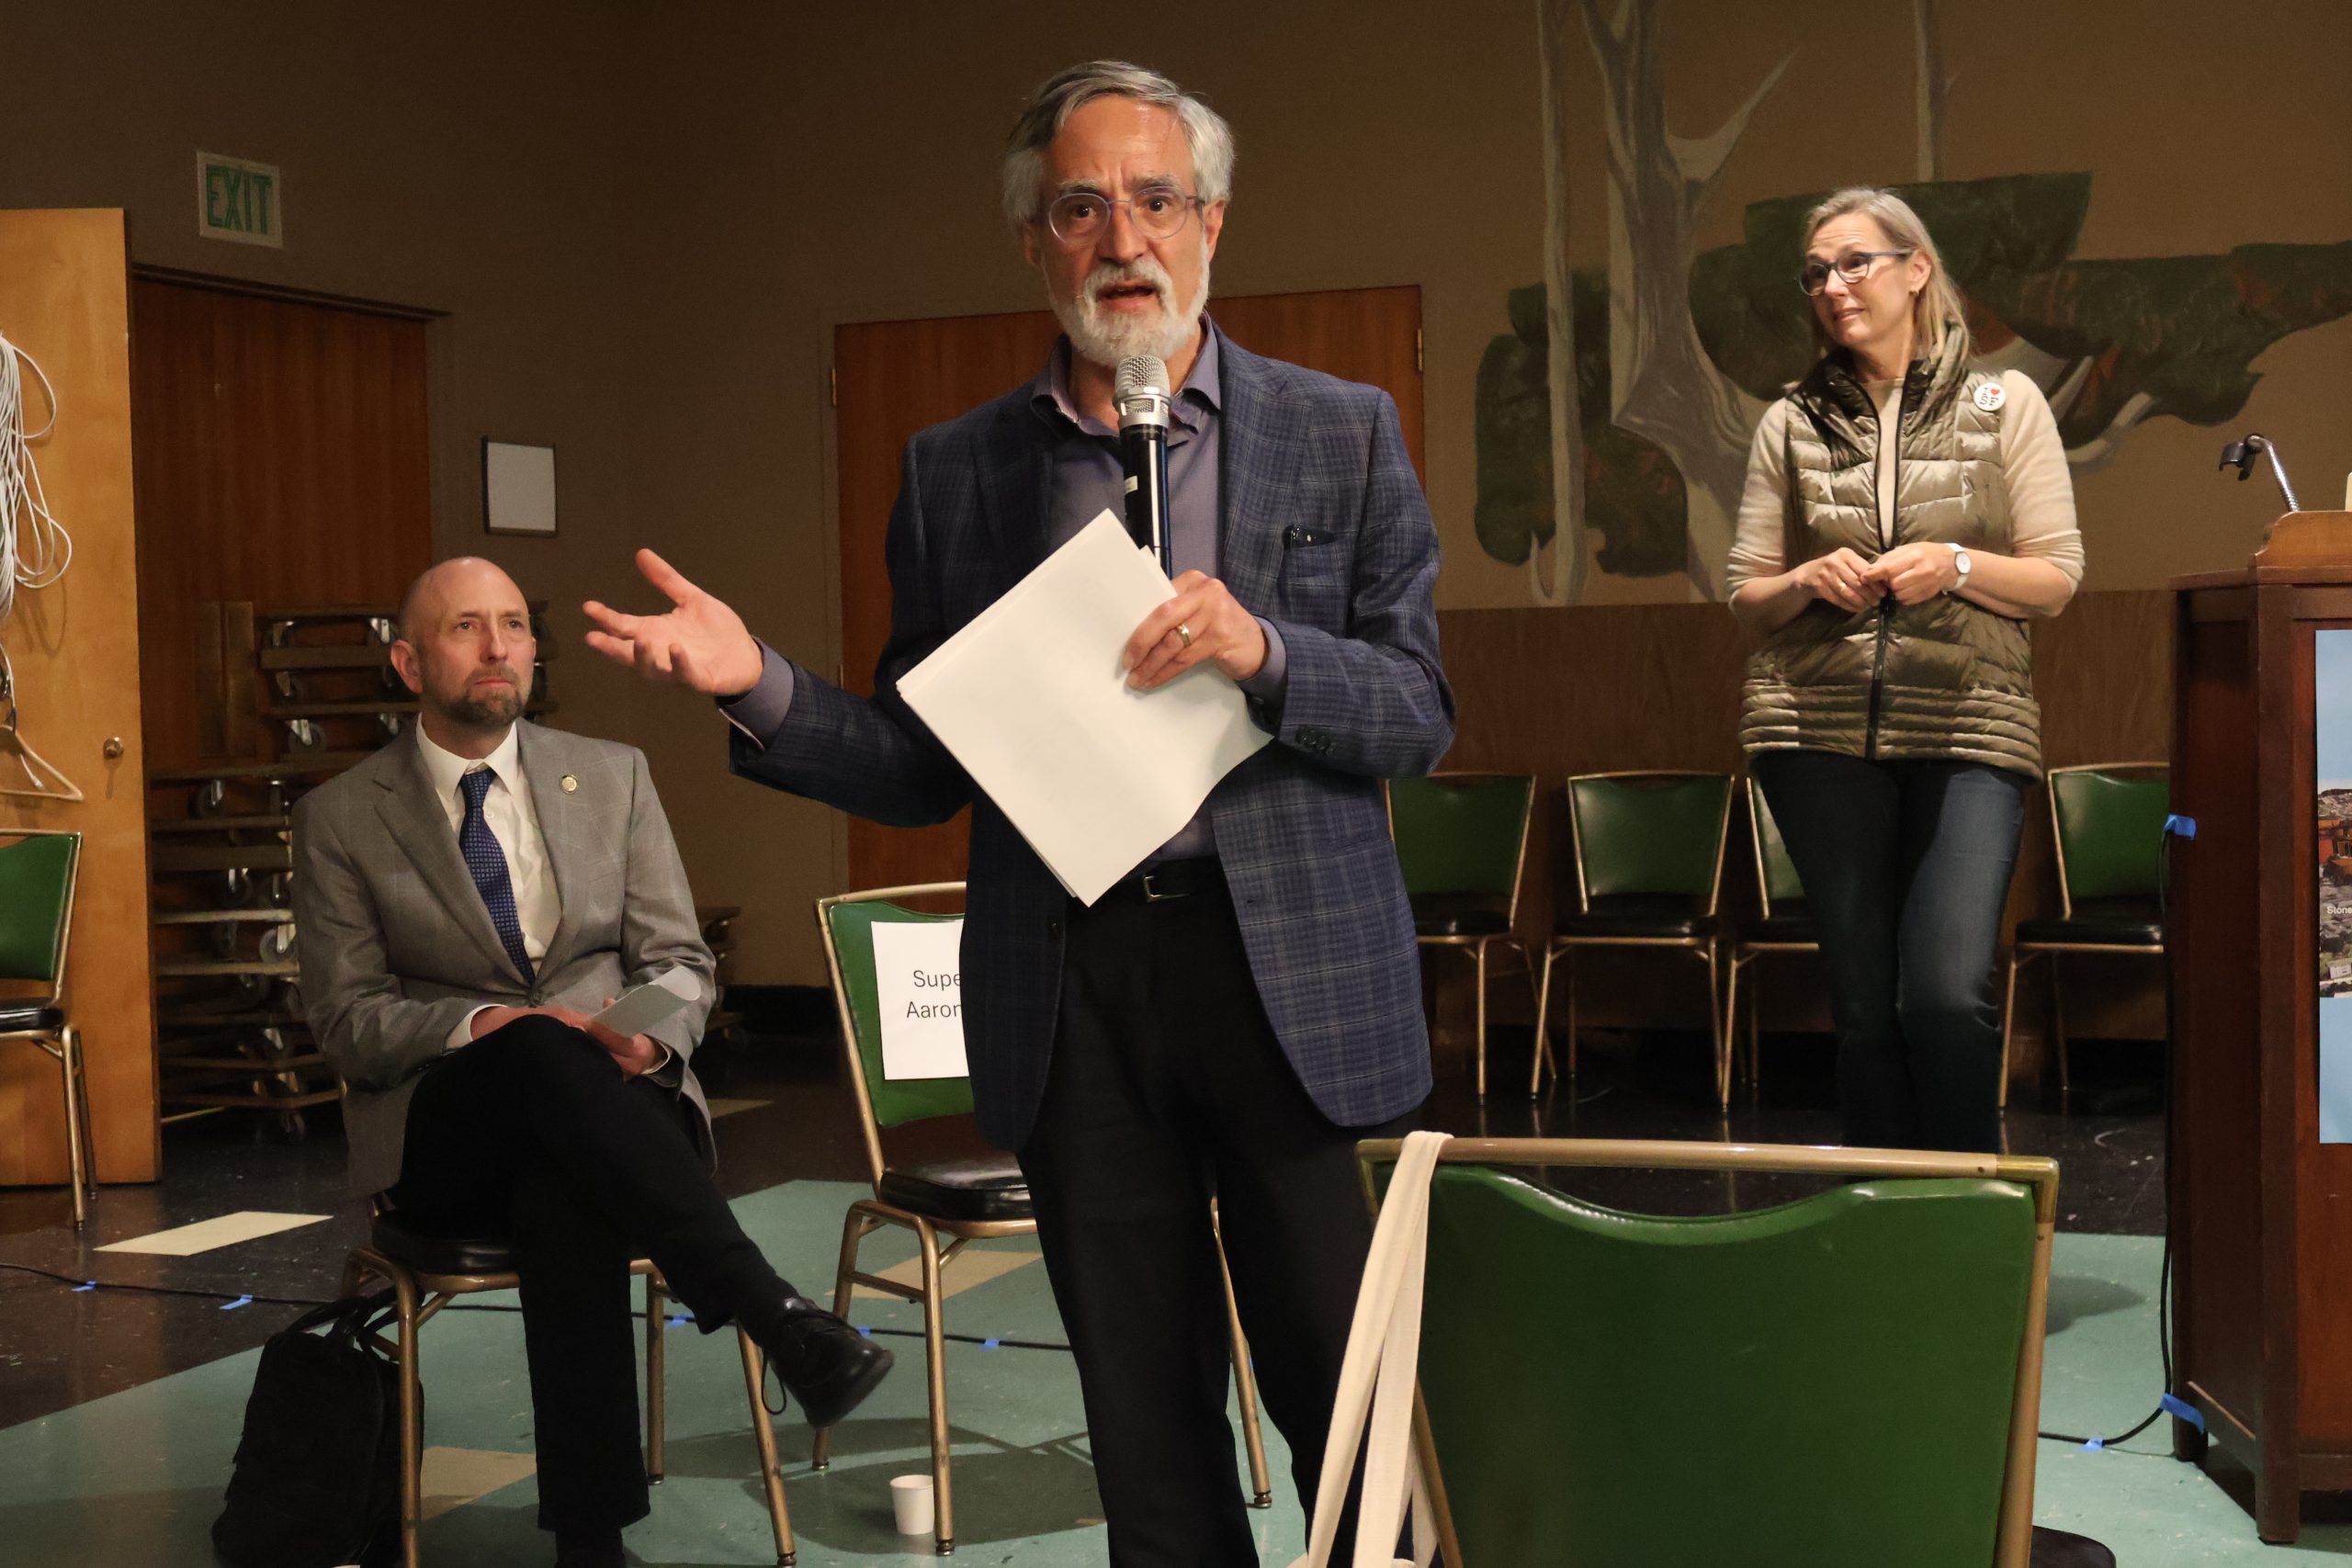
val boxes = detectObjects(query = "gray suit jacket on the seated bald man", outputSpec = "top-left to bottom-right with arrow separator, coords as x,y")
294,722 -> 718,1192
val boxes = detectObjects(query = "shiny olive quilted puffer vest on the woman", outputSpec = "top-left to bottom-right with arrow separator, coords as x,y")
1740,341 -> 2041,778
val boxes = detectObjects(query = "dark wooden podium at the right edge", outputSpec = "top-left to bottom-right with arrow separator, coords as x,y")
2166,513 -> 2352,1542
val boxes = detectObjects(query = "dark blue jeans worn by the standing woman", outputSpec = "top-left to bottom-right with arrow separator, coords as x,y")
1750,752 -> 2032,1155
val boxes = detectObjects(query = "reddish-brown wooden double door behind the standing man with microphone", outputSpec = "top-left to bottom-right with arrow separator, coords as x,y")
832,287 -> 1425,888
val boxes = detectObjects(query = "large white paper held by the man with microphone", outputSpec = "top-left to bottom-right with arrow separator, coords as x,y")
899,510 -> 1270,905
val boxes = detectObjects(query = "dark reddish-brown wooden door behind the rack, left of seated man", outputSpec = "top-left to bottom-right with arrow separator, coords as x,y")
131,275 -> 433,769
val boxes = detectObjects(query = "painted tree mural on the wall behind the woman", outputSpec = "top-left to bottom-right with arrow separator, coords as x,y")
1477,0 -> 2352,604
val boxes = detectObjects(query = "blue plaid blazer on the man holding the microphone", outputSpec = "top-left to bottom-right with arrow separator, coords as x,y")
731,327 -> 1453,1149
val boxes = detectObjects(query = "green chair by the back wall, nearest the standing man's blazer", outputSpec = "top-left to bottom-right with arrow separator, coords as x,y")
1387,773 -> 1536,1100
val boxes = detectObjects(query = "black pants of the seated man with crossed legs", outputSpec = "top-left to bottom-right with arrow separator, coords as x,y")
390,1016 -> 793,1530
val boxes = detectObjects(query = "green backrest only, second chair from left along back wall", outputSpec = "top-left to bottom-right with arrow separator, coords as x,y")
1569,773 -> 1731,915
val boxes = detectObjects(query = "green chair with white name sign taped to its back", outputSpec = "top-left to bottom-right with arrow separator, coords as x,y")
809,882 -> 1275,1556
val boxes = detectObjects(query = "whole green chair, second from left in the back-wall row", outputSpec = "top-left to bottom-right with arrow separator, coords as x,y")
1526,771 -> 1731,1110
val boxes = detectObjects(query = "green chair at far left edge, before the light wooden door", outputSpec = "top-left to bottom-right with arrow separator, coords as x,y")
0,828 -> 99,1229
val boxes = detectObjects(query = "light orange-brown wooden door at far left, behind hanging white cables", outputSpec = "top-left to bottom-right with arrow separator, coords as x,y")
0,209 -> 160,1185
